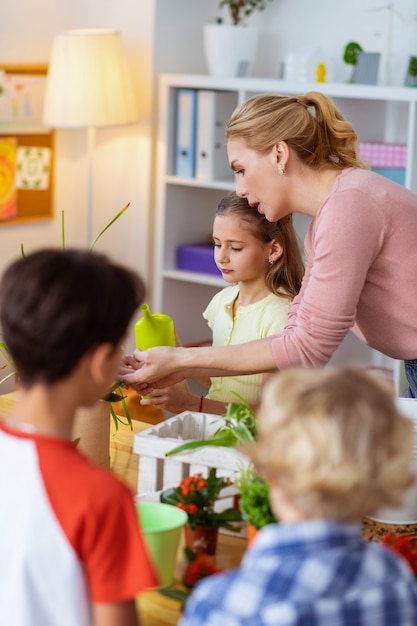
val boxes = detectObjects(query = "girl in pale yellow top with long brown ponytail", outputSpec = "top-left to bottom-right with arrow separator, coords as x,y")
134,193 -> 304,415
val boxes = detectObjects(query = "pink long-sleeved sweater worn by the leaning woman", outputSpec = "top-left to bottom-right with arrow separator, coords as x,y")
272,169 -> 417,369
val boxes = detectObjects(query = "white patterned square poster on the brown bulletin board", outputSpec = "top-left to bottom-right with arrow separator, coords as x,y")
16,146 -> 51,189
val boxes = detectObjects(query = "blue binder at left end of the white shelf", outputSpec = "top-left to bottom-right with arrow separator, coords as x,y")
174,89 -> 197,178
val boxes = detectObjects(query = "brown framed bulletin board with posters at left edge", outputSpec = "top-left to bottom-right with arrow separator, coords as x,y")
0,64 -> 54,227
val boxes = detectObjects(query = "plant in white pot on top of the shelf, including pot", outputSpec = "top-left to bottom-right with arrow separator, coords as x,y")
204,0 -> 271,76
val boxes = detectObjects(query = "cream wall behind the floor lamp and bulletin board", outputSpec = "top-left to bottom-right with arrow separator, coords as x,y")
0,0 -> 154,356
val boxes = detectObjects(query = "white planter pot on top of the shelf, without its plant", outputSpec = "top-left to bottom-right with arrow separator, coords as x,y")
204,24 -> 258,76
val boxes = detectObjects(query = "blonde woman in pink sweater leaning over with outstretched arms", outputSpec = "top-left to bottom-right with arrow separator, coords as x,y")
120,92 -> 417,397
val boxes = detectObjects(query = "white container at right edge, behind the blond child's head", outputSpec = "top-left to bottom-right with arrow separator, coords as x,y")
369,398 -> 417,524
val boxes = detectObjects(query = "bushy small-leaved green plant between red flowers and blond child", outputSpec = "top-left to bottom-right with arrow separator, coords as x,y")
234,465 -> 277,530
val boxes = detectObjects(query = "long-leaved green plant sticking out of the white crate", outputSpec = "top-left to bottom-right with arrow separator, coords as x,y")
166,393 -> 256,456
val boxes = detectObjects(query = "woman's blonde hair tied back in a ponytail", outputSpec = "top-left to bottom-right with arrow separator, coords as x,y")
226,91 -> 369,170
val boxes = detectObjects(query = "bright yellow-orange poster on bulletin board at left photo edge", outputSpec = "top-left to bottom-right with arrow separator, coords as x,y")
0,137 -> 17,220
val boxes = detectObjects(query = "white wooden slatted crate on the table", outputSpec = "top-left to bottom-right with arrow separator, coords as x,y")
133,411 -> 249,499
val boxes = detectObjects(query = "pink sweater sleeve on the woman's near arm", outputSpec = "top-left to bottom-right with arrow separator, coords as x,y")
272,191 -> 386,369
